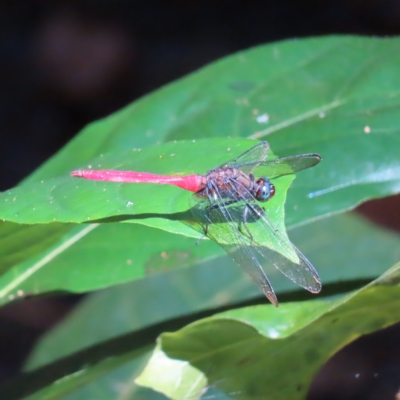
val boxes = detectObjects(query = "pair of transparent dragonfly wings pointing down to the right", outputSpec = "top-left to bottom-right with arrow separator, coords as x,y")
188,177 -> 321,305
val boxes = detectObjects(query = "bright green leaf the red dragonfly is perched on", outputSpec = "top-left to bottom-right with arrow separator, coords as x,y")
0,139 -> 291,231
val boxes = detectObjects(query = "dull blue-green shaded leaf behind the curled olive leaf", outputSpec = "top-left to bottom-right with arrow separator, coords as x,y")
0,215 -> 400,399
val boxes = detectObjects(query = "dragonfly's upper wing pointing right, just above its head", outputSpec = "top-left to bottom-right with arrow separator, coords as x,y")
257,153 -> 322,179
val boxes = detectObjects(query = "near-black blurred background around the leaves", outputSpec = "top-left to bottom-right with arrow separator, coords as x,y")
0,0 -> 400,400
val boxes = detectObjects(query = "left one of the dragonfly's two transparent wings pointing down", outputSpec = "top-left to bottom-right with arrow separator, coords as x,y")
191,181 -> 278,307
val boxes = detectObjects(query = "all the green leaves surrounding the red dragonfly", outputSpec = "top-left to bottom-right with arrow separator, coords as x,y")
0,37 -> 400,399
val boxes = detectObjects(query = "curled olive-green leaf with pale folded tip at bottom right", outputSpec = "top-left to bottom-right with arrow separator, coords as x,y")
137,264 -> 400,399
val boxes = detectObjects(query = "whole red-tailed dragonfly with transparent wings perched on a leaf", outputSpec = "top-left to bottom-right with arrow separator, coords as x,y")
71,141 -> 322,307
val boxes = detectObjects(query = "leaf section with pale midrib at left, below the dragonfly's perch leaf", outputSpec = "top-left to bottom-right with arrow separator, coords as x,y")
0,223 -> 221,304
